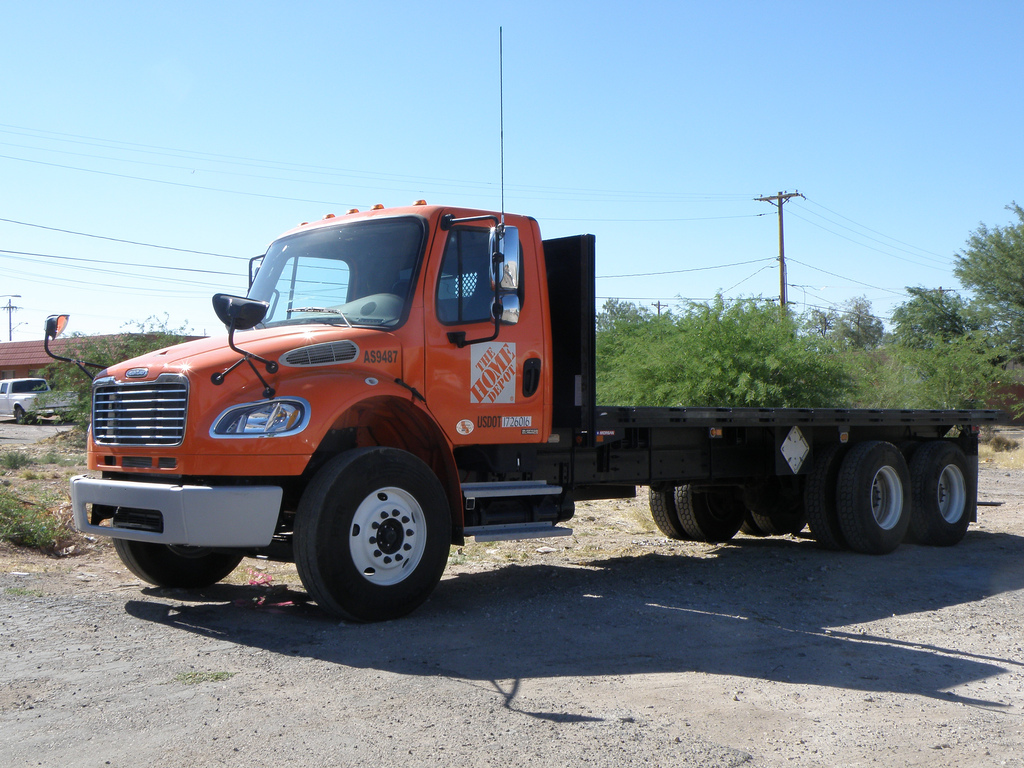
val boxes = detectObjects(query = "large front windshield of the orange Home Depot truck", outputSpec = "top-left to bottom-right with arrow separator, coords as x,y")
249,216 -> 426,328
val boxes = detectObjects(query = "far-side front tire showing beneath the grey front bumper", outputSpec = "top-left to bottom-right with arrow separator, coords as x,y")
114,539 -> 242,589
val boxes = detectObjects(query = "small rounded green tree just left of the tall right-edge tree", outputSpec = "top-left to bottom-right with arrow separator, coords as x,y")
892,286 -> 982,349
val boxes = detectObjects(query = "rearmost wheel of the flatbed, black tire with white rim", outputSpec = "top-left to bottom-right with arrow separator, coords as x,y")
910,440 -> 978,547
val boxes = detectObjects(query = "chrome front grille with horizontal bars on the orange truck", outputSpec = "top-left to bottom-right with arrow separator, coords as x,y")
92,375 -> 188,445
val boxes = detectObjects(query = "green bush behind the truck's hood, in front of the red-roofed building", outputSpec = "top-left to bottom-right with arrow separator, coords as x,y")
45,315 -> 193,425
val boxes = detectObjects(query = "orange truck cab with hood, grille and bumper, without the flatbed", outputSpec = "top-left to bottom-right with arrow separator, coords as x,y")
72,204 -> 571,617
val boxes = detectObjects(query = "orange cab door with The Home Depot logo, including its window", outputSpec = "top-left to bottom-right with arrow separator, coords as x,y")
424,224 -> 550,445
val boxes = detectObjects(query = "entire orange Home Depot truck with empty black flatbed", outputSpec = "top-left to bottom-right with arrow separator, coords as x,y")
46,202 -> 1004,621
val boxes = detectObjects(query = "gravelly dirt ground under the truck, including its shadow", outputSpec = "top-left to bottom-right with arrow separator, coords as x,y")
0,436 -> 1024,768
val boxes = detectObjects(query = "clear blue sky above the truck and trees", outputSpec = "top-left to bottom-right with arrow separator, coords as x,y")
0,0 -> 1024,341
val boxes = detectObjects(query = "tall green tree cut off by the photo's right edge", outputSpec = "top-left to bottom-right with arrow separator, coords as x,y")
953,203 -> 1024,359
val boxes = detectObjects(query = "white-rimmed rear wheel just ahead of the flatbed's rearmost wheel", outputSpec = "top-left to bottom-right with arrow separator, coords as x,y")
836,440 -> 910,555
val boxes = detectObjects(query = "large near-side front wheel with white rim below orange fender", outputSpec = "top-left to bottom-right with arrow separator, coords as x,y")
294,447 -> 452,622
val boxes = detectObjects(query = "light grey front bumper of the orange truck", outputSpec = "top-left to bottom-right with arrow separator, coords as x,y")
71,475 -> 284,547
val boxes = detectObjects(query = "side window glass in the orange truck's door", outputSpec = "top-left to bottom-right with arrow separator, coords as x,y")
437,227 -> 495,324
